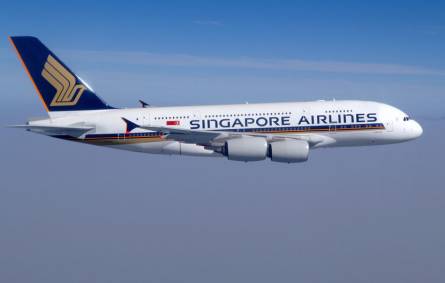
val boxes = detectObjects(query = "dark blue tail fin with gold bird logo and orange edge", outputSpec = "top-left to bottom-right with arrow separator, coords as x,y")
9,36 -> 112,112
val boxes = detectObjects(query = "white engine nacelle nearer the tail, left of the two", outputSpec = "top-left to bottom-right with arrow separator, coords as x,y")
223,137 -> 267,162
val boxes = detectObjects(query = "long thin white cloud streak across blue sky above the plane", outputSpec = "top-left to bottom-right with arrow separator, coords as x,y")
63,51 -> 445,76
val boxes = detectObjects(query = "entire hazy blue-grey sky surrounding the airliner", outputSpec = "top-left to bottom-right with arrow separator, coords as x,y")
0,1 -> 445,283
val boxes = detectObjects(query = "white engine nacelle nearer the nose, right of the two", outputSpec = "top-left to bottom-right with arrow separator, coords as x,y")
268,140 -> 309,163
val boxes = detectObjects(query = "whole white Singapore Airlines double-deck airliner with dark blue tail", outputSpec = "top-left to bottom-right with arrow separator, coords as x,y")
9,36 -> 422,163
